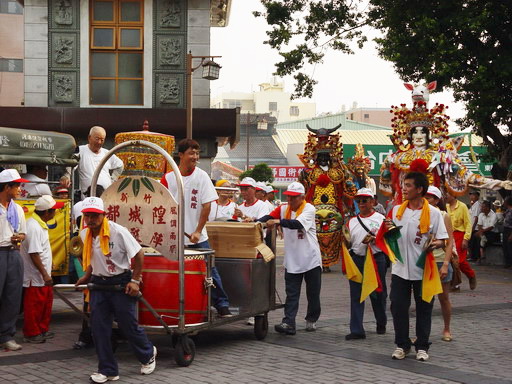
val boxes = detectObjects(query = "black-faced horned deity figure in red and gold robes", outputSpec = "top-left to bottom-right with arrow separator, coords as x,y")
298,125 -> 357,272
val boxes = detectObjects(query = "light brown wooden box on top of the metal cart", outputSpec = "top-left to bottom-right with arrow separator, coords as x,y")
206,221 -> 274,261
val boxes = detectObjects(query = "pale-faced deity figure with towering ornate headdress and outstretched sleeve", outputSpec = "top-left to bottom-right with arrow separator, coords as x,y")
379,101 -> 512,204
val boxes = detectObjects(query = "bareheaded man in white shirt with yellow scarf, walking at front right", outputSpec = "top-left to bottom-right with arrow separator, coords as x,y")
385,172 -> 448,361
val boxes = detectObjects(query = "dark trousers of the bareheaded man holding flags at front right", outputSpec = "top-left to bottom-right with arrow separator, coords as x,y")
389,275 -> 434,351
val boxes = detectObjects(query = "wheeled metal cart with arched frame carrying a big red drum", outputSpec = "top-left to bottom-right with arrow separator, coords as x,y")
60,140 -> 282,366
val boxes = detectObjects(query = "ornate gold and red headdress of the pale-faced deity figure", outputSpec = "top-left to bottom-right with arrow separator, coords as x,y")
390,101 -> 450,151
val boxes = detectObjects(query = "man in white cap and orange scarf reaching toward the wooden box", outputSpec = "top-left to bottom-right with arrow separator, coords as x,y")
258,182 -> 322,335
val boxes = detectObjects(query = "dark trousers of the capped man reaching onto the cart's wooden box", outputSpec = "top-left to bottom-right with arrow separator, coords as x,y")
283,267 -> 322,327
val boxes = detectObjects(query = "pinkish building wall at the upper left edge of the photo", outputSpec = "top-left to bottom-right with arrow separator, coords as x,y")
0,13 -> 25,107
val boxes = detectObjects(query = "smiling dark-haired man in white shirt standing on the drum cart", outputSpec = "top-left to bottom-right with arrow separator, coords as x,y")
160,139 -> 232,317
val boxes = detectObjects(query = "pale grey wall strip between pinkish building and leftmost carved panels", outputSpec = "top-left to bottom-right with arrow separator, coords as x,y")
25,0 -> 48,107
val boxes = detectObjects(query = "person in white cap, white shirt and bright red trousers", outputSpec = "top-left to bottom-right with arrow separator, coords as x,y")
21,195 -> 64,343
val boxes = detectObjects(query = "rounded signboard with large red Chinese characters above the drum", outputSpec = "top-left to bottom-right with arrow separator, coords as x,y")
101,176 -> 183,260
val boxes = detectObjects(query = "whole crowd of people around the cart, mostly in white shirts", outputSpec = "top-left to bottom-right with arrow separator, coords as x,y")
0,127 -> 512,383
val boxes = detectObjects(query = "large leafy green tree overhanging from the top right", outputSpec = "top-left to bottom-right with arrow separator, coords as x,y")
255,0 -> 512,178
